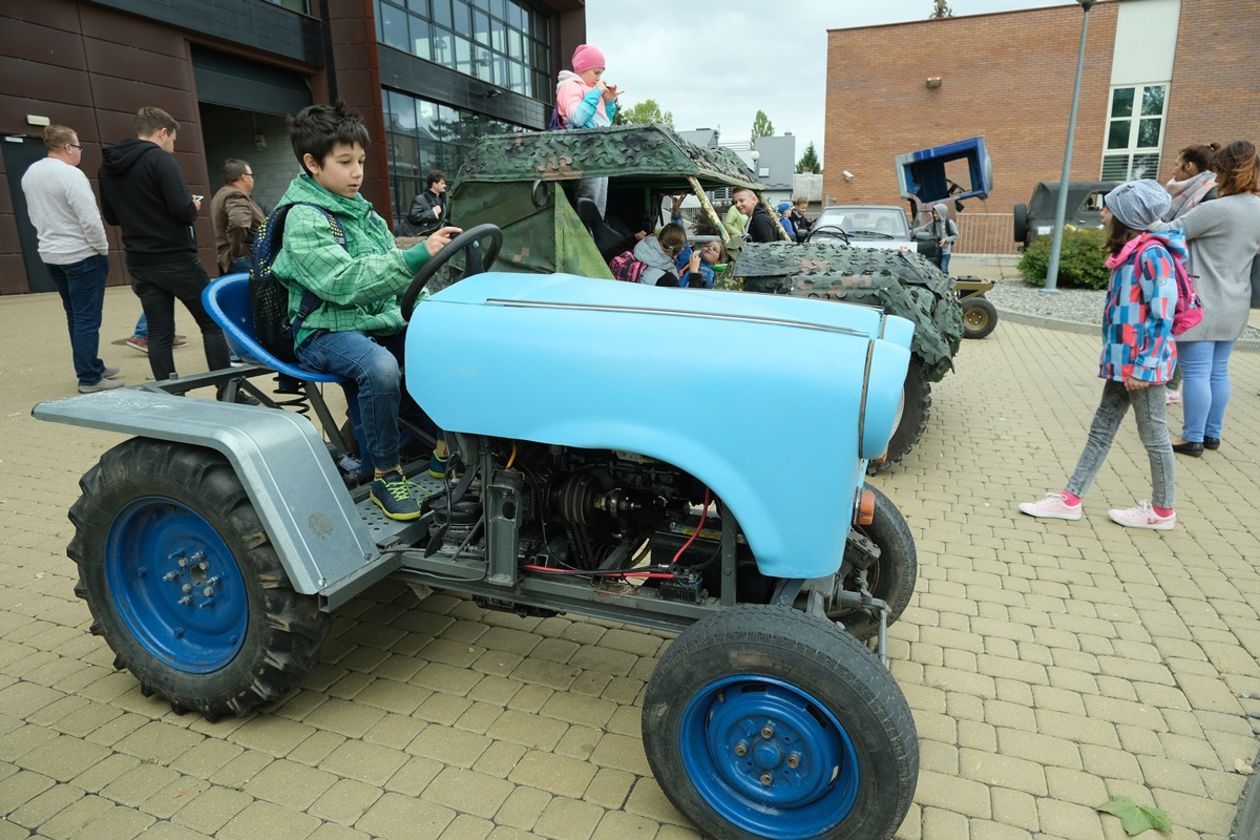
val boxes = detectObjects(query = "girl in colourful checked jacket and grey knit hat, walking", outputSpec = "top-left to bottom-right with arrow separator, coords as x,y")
1019,180 -> 1186,530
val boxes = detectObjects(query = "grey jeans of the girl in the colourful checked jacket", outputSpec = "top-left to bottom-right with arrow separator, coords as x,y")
1067,379 -> 1174,508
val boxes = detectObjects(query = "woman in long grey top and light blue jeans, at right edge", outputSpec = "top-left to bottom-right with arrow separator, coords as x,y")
1152,140 -> 1260,458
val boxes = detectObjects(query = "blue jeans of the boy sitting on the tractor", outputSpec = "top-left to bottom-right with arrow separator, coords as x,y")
297,331 -> 403,470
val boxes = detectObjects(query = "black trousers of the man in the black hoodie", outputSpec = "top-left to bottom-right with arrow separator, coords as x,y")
127,254 -> 231,382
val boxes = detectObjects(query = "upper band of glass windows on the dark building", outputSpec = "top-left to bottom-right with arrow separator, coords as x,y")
374,0 -> 553,102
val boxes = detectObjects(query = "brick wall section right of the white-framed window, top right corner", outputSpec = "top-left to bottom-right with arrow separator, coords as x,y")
1160,0 -> 1260,168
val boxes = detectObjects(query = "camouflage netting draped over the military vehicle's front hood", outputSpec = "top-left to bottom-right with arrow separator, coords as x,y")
733,243 -> 963,382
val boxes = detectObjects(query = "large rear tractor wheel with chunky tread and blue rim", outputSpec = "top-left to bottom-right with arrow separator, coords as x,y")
67,438 -> 331,720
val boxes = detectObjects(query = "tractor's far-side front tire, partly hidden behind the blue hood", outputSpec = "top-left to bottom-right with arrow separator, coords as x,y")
827,485 -> 919,641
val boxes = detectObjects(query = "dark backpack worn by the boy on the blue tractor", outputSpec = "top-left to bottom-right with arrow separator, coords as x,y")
249,201 -> 345,364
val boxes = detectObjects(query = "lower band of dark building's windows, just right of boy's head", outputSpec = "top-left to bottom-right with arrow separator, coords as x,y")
381,89 -> 525,219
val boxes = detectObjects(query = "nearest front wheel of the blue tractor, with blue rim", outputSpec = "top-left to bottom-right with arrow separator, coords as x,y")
643,604 -> 919,840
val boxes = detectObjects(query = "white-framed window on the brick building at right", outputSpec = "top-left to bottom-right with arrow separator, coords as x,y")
1103,83 -> 1168,181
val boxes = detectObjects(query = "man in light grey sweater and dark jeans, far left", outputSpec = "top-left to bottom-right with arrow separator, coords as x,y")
21,125 -> 122,394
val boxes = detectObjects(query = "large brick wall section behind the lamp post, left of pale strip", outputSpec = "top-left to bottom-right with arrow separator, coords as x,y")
823,0 -> 1123,213
